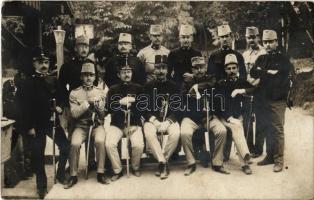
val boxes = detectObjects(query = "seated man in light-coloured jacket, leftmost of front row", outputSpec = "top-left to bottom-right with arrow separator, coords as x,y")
65,62 -> 109,189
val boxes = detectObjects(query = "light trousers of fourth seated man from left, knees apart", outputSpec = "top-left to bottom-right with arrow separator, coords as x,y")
181,116 -> 227,166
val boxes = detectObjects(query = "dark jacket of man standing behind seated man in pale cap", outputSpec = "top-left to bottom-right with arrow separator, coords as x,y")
208,48 -> 247,81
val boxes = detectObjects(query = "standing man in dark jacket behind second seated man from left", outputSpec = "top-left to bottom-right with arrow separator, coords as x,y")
103,33 -> 146,87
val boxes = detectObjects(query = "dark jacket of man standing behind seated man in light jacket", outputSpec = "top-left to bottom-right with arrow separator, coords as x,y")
59,56 -> 96,106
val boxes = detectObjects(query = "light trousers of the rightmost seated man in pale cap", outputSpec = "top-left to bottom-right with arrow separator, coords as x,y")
221,119 -> 250,165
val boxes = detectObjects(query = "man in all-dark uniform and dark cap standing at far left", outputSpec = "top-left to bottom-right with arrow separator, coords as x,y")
17,48 -> 70,198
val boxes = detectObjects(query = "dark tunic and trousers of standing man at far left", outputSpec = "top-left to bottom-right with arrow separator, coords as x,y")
17,73 -> 70,189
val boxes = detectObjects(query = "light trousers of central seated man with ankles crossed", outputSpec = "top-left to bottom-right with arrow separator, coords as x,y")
144,122 -> 180,163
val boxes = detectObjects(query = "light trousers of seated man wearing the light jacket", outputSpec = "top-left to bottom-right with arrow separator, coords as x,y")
69,126 -> 106,176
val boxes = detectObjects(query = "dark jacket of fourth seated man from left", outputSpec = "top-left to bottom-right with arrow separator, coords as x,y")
182,75 -> 216,124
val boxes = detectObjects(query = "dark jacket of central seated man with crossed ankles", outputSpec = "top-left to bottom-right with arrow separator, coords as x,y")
143,80 -> 181,123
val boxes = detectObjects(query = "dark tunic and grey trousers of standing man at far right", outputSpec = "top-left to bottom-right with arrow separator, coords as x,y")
250,50 -> 293,164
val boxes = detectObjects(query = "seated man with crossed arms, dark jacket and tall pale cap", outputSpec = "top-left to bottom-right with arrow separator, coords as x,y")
219,54 -> 253,175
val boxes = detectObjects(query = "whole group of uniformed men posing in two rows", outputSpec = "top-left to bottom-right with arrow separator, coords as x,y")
1,22 -> 293,197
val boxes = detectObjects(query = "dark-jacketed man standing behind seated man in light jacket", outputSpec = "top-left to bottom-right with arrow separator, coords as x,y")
59,35 -> 98,170
